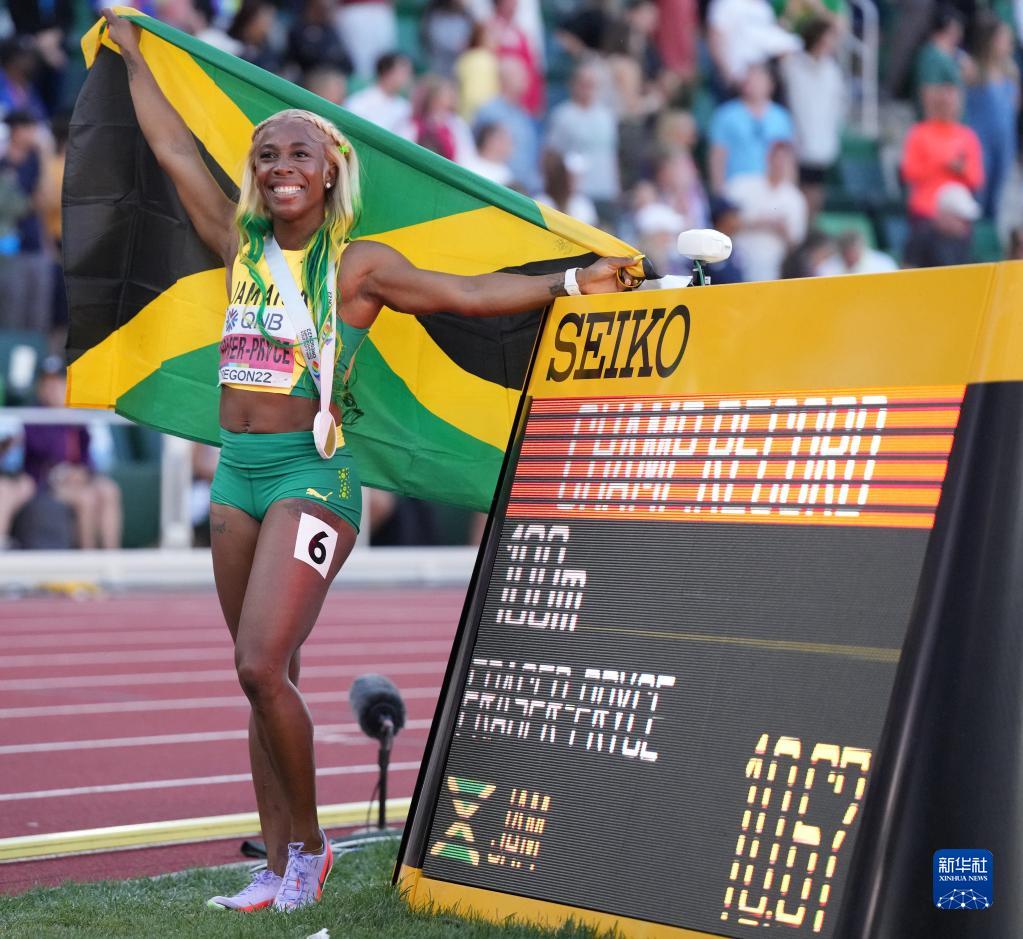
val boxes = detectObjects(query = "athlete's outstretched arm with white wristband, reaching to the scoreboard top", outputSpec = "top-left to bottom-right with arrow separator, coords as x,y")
340,241 -> 635,325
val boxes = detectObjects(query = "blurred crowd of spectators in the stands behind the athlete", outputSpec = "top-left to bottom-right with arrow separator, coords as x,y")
0,0 -> 1023,546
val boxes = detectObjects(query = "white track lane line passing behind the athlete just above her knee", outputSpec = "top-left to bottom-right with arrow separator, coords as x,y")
0,617 -> 458,651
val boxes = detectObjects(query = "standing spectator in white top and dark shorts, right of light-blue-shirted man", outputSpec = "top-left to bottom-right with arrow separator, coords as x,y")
782,18 -> 849,216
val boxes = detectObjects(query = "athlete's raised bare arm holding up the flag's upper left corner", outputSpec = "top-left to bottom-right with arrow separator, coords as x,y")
102,9 -> 235,265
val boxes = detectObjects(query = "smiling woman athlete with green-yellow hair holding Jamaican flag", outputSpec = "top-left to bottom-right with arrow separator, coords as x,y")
97,10 -> 634,911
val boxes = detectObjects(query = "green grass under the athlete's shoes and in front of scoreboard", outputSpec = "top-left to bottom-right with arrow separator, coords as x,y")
0,844 -> 607,939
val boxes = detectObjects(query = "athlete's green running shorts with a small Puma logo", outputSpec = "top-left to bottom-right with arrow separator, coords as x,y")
210,429 -> 362,531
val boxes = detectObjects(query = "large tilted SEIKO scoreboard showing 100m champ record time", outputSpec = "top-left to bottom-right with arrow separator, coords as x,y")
397,264 -> 1023,939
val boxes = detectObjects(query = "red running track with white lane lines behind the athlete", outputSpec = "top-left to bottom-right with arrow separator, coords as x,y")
0,587 -> 464,893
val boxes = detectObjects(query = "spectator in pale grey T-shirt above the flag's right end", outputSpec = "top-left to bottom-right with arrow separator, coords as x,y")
547,62 -> 620,221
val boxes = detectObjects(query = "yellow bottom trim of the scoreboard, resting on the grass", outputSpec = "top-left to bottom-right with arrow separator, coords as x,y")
398,864 -> 725,939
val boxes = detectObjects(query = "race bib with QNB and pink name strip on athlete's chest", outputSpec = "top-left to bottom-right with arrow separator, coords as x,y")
220,305 -> 295,389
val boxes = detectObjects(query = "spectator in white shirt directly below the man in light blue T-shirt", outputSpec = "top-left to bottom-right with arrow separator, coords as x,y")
725,140 -> 807,280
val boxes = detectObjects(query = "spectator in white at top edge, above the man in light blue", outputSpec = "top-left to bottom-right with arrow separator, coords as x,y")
707,0 -> 801,88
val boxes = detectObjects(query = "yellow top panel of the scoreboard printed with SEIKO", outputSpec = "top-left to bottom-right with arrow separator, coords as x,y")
529,262 -> 1023,398
